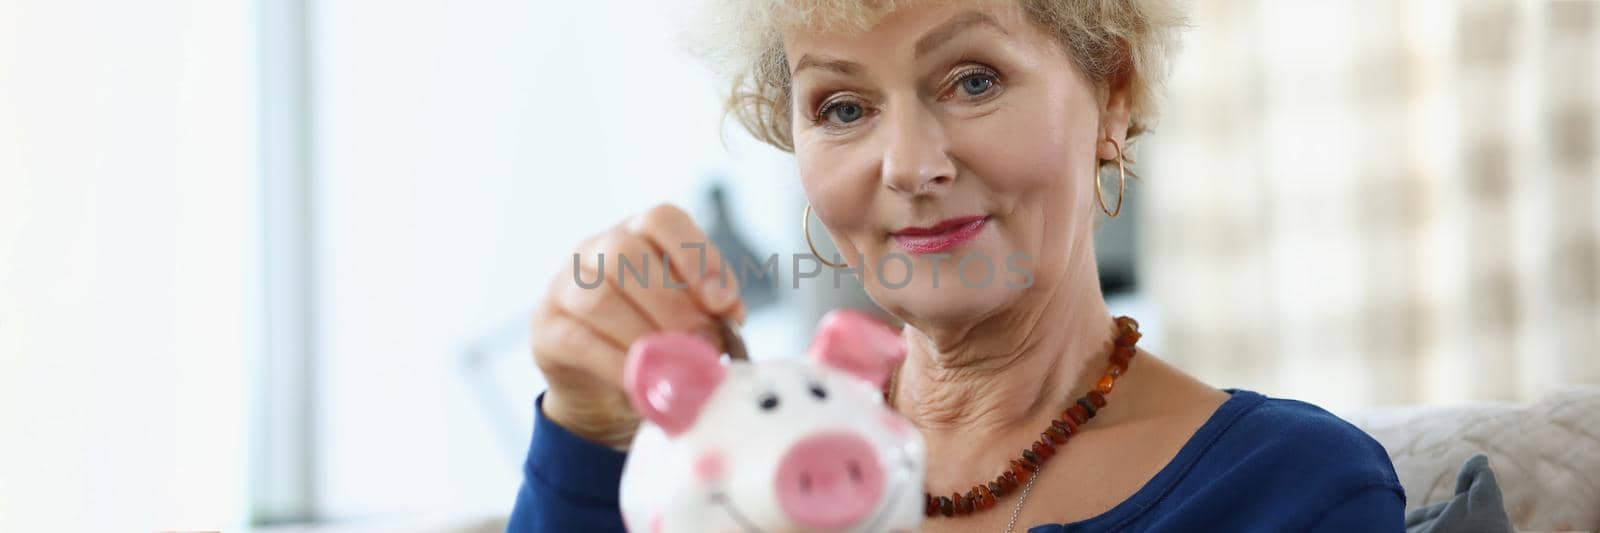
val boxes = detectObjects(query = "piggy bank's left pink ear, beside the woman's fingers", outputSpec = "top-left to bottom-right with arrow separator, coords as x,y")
622,333 -> 726,435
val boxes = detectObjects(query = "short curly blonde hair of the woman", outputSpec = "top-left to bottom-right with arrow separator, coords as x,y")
690,0 -> 1184,152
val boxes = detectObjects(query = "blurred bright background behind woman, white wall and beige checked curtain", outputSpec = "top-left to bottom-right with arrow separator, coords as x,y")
0,0 -> 1600,531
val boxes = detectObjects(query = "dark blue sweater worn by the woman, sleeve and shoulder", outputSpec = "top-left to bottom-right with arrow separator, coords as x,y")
506,389 -> 1405,533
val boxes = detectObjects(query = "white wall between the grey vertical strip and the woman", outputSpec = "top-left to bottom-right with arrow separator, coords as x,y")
312,0 -> 798,517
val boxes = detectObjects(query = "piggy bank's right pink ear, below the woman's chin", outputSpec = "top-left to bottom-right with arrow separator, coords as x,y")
811,309 -> 906,387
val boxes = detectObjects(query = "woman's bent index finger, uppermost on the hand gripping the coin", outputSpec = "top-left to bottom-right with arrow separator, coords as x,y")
626,205 -> 744,320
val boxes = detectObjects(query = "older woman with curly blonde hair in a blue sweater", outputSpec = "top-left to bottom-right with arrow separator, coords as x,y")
510,0 -> 1405,531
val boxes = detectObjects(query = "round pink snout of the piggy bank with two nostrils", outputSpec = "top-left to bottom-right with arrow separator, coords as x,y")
778,432 -> 885,528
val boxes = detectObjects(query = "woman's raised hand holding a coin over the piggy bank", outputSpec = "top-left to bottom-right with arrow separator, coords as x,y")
533,205 -> 744,448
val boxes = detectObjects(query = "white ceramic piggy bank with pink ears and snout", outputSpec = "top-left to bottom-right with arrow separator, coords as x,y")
621,311 -> 925,533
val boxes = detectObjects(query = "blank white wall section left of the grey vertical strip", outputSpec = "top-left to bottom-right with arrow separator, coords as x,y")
0,0 -> 258,531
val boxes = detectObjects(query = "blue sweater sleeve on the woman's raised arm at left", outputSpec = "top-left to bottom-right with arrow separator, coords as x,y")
506,394 -> 627,533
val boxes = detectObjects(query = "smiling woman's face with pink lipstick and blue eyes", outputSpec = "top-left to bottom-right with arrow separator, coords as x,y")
784,2 -> 1128,325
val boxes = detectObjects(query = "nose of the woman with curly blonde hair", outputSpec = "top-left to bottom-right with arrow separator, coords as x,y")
880,104 -> 955,195
